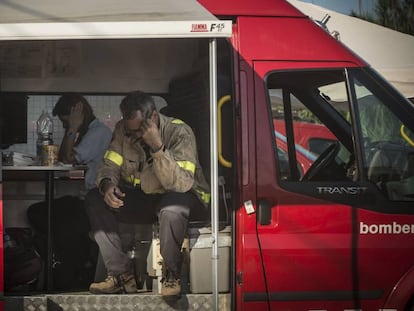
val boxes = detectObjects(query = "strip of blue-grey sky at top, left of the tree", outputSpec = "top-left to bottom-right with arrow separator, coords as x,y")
300,0 -> 376,15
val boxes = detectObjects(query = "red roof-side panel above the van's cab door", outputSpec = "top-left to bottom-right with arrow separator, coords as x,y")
199,0 -> 366,69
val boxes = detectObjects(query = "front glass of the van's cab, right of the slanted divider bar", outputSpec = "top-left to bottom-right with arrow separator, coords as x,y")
355,79 -> 414,201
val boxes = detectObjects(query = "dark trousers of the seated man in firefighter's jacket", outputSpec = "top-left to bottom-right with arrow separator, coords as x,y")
85,188 -> 204,277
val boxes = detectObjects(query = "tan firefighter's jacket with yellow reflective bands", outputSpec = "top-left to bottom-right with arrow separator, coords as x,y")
96,114 -> 210,205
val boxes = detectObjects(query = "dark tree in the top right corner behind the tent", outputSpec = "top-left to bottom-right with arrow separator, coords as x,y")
351,0 -> 414,35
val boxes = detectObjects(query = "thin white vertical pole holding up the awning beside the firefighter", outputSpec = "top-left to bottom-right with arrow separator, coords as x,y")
209,39 -> 219,310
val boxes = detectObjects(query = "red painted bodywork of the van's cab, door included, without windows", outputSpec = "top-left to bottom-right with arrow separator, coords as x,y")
199,0 -> 414,310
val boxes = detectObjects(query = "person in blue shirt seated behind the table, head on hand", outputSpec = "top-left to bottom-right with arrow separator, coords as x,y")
27,94 -> 112,290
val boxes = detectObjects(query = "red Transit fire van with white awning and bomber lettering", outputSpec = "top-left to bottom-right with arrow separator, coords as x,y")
0,0 -> 414,311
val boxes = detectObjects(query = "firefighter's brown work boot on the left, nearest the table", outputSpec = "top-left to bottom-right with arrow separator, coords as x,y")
89,272 -> 137,294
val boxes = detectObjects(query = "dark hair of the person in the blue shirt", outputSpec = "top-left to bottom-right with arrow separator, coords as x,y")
52,93 -> 95,142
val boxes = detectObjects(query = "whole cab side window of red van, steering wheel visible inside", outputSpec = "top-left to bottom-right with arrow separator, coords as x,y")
266,70 -> 414,201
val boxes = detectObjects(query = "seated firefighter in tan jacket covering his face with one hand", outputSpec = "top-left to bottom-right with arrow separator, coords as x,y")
85,91 -> 210,296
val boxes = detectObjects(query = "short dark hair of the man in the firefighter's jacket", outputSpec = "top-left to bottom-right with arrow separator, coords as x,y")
119,91 -> 156,120
